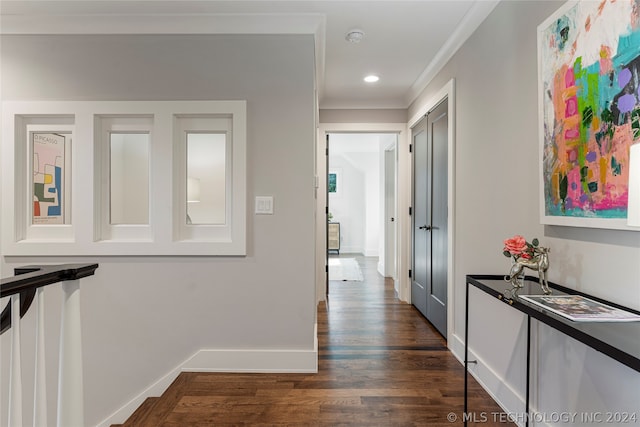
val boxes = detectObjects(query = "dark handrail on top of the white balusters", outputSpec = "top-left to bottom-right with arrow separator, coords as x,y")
0,264 -> 98,334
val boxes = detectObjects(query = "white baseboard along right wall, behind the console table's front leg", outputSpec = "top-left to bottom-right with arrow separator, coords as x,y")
447,334 -> 525,427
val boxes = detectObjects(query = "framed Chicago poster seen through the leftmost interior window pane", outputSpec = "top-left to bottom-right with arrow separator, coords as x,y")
31,133 -> 65,224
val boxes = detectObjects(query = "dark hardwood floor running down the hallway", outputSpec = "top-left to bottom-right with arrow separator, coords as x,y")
115,254 -> 514,427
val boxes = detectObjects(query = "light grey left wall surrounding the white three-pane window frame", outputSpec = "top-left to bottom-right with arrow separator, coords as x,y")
0,35 -> 316,425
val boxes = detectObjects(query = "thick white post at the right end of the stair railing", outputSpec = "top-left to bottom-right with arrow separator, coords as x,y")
57,280 -> 84,427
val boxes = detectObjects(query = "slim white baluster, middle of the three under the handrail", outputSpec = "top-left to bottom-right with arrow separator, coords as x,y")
33,288 -> 47,427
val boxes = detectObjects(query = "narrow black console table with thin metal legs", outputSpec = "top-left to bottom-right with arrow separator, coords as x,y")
464,275 -> 640,426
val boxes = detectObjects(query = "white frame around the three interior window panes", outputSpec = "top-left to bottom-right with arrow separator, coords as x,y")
1,101 -> 247,256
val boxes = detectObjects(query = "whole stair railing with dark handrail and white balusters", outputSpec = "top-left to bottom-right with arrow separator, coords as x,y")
0,264 -> 98,427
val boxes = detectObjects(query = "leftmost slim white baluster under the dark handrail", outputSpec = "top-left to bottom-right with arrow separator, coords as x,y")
8,294 -> 22,426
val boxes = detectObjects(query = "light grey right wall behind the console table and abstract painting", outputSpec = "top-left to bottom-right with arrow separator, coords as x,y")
409,1 -> 640,422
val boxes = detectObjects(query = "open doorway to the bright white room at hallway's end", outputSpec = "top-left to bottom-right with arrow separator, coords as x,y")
326,133 -> 398,294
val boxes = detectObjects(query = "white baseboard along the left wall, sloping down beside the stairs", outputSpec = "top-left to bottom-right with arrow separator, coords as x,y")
96,338 -> 318,427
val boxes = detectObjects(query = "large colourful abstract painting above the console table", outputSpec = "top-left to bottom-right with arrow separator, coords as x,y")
538,0 -> 640,229
